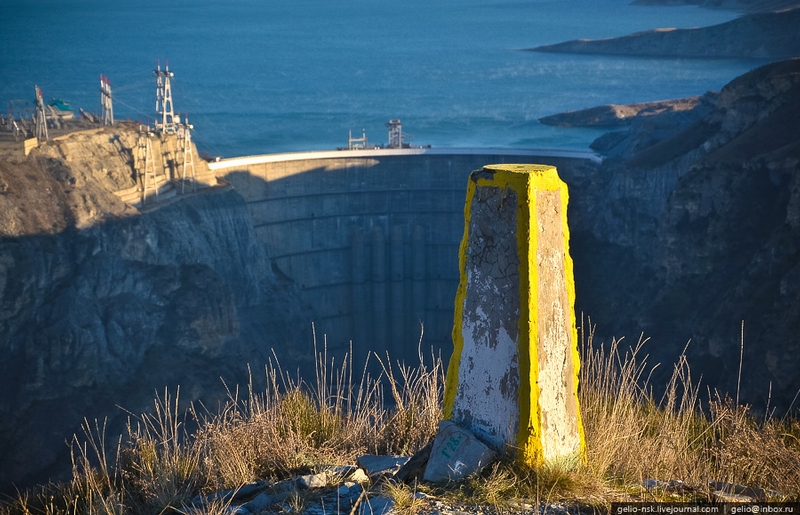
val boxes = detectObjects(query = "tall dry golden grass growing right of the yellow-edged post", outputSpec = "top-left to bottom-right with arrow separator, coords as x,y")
581,320 -> 800,500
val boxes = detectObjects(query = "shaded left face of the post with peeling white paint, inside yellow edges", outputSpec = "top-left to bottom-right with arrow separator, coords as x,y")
446,183 -> 520,450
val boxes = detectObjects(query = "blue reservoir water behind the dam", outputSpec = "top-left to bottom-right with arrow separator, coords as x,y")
0,0 -> 762,157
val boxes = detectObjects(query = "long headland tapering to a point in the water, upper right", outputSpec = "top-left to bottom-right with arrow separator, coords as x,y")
530,7 -> 800,59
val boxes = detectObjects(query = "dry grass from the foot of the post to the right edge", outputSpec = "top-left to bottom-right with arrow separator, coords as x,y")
390,322 -> 800,513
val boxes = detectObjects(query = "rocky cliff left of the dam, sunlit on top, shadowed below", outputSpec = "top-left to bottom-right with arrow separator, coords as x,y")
0,127 -> 311,492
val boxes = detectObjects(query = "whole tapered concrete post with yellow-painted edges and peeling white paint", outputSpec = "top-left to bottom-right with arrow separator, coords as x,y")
445,165 -> 585,465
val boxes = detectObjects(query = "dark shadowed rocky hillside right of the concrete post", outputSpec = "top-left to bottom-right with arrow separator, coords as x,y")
567,59 -> 800,416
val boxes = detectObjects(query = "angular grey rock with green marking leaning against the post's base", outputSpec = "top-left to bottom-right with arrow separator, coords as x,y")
423,420 -> 496,483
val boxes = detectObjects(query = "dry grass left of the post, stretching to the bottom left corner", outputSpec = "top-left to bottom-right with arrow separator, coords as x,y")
0,338 -> 444,515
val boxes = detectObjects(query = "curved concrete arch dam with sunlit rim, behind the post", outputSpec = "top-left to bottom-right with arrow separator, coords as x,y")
209,149 -> 599,364
